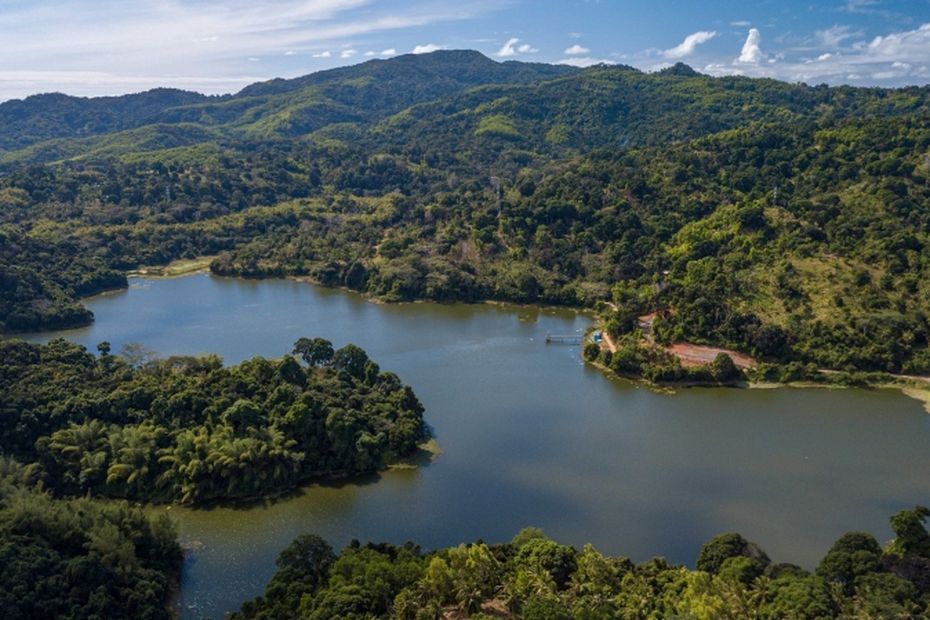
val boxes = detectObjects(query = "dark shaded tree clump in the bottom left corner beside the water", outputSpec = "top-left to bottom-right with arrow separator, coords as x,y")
0,458 -> 181,620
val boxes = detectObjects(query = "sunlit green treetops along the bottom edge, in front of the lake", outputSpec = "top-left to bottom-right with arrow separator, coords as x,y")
233,508 -> 930,620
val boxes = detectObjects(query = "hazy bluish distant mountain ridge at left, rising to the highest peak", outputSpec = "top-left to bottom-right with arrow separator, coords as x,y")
0,51 -> 576,160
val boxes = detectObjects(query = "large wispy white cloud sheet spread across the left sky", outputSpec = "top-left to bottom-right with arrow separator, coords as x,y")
0,0 -> 505,101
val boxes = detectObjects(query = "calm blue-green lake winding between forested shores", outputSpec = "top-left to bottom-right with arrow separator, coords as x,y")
20,274 -> 930,618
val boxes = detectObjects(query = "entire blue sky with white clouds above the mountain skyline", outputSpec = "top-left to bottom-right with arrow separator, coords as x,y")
0,0 -> 930,101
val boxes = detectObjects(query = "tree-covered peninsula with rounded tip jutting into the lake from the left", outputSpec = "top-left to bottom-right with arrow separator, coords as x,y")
0,338 -> 427,504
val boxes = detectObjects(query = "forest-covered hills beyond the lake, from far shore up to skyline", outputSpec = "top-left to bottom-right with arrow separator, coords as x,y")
0,52 -> 930,376
